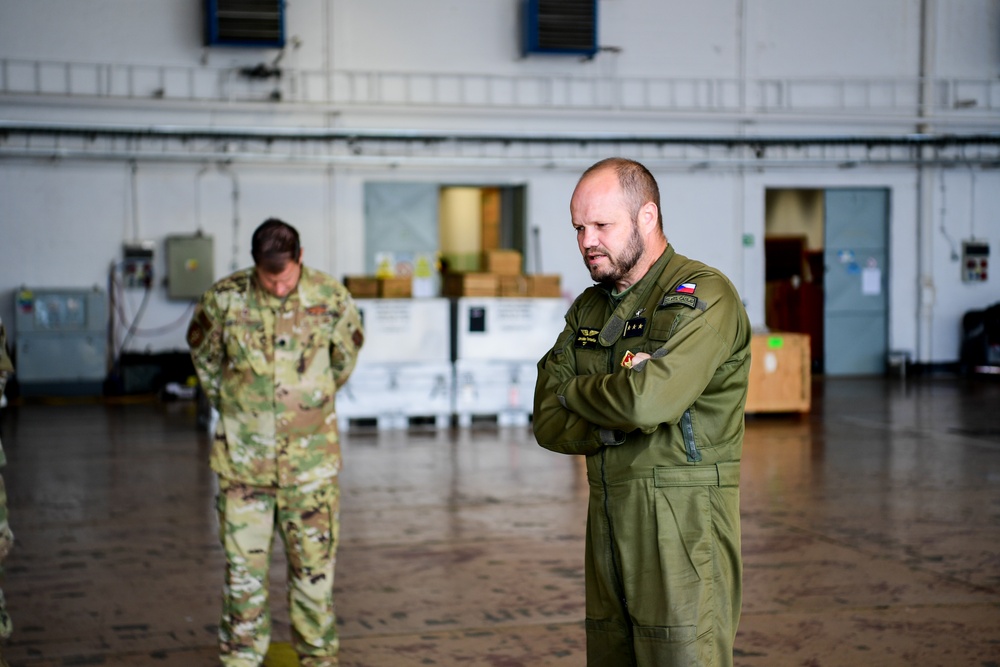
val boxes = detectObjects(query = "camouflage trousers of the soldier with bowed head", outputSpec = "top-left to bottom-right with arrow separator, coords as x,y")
217,478 -> 340,667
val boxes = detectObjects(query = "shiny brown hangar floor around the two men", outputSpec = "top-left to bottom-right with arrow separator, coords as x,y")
0,377 -> 1000,667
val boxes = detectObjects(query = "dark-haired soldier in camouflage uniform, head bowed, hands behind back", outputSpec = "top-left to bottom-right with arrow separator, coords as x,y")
187,218 -> 364,667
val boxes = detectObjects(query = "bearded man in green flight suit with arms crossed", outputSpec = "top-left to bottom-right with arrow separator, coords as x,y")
533,158 -> 751,667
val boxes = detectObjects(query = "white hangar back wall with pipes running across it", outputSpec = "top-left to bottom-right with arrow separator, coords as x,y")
0,0 -> 1000,363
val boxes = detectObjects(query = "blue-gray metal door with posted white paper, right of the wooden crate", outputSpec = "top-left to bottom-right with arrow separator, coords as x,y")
823,188 -> 889,375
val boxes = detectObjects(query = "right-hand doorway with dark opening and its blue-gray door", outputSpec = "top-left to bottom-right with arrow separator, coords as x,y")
764,188 -> 889,375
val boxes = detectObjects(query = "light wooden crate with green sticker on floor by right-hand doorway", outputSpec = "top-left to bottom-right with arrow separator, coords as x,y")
746,333 -> 812,414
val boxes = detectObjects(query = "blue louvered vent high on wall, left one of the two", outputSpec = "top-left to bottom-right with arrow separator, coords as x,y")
205,0 -> 285,48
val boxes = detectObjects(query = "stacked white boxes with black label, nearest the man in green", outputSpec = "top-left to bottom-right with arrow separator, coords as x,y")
452,297 -> 566,426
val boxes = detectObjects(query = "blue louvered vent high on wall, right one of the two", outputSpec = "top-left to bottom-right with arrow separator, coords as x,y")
524,0 -> 597,58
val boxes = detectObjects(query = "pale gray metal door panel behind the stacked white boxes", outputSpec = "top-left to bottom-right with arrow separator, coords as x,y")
364,183 -> 440,274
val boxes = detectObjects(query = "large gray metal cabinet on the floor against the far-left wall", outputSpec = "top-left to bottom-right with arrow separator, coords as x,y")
14,287 -> 108,395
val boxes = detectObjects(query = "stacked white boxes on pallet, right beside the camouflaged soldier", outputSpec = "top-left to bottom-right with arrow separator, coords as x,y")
337,299 -> 453,429
